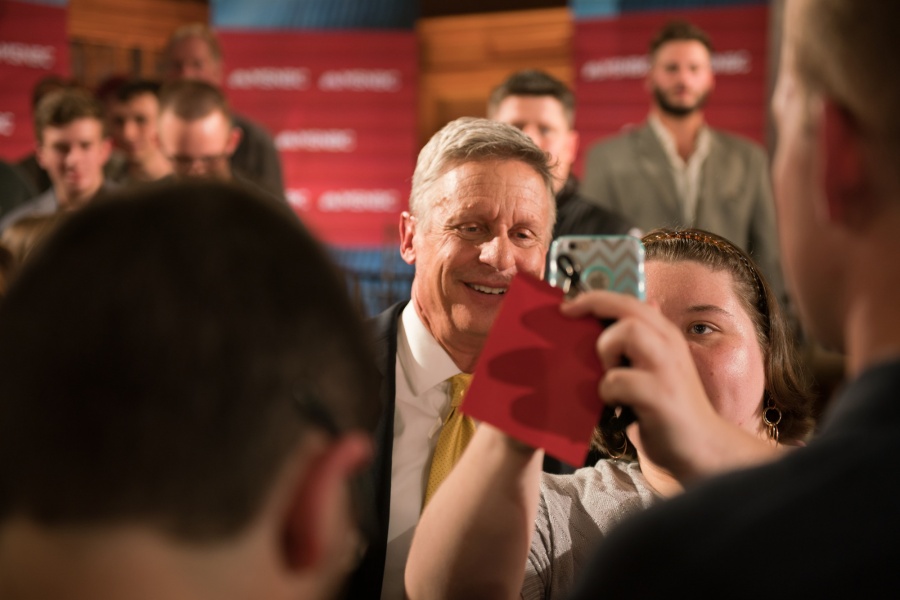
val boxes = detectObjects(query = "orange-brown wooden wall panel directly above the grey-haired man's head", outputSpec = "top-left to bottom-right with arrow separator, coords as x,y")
417,8 -> 573,144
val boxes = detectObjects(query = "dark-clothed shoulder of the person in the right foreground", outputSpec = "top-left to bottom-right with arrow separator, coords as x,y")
574,361 -> 900,600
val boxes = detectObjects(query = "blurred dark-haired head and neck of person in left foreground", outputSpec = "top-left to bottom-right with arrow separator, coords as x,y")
0,181 -> 380,600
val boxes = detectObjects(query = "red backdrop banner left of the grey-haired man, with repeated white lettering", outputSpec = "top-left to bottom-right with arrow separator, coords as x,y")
220,30 -> 418,246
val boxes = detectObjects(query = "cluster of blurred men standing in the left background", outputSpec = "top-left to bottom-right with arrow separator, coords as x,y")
0,24 -> 284,290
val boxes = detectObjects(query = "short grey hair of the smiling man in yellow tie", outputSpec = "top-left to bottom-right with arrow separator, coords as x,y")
409,117 -> 556,234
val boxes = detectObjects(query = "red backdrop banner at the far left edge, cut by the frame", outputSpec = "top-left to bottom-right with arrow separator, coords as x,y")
0,0 -> 69,161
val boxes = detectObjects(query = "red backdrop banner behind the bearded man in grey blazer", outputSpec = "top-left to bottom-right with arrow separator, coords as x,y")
575,5 -> 768,178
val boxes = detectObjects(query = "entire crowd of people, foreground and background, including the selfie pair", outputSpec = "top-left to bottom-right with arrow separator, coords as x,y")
0,0 -> 900,600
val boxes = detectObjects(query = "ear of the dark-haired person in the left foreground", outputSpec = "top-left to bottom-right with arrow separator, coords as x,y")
282,433 -> 372,574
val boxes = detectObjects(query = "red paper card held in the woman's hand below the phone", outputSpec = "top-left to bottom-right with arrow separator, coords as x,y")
462,274 -> 603,467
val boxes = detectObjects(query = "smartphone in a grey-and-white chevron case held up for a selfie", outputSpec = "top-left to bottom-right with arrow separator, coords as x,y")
547,235 -> 645,300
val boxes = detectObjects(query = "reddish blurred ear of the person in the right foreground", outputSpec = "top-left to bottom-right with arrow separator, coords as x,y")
819,98 -> 877,230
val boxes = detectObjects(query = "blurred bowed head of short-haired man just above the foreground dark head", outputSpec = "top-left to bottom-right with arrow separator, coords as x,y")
159,80 -> 244,185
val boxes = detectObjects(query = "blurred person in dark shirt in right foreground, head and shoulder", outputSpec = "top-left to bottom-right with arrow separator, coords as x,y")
575,0 -> 900,599
